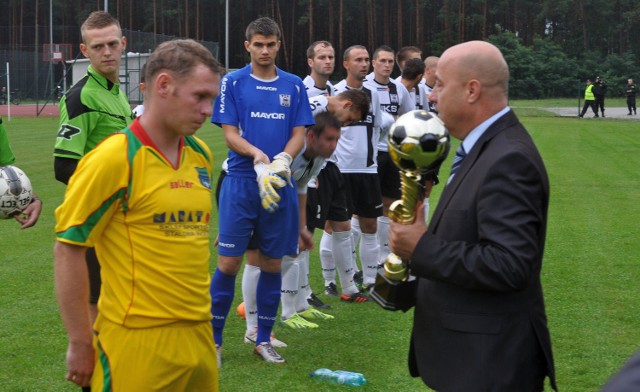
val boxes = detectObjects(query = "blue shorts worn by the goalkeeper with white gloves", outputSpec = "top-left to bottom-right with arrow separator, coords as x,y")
218,175 -> 300,259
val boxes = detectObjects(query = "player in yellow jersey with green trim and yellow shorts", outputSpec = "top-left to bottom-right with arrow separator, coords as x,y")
54,40 -> 224,392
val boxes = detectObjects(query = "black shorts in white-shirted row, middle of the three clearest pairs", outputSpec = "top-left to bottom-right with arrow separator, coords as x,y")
342,173 -> 382,218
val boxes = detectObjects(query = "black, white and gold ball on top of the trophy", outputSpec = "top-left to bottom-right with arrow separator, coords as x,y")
388,110 -> 450,174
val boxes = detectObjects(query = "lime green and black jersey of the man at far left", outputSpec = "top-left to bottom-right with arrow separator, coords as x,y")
53,66 -> 134,159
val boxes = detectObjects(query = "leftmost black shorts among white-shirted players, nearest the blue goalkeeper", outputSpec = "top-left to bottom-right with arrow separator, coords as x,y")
307,162 -> 351,229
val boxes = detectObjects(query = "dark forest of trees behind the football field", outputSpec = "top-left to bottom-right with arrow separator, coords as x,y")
0,0 -> 640,98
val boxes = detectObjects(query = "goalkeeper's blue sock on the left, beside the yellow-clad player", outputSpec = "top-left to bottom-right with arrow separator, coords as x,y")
209,268 -> 236,346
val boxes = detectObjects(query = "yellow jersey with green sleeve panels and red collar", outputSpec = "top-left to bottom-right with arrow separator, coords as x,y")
56,121 -> 213,328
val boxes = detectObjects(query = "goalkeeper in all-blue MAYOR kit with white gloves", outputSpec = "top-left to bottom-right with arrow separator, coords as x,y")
211,18 -> 314,363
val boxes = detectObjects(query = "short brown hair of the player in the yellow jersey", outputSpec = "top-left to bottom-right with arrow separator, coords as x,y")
144,39 -> 226,81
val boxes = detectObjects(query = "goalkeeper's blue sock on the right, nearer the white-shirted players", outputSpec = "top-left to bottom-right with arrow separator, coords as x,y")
256,271 -> 282,345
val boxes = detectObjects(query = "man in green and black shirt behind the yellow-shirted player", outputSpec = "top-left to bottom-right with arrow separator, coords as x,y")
53,11 -> 134,328
